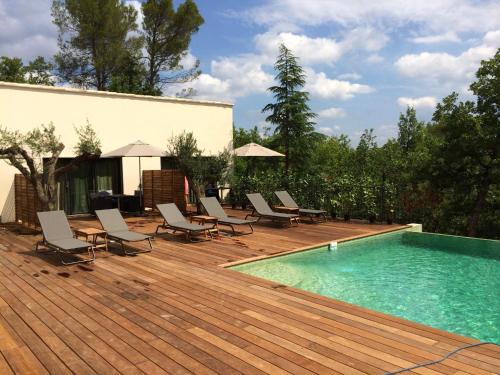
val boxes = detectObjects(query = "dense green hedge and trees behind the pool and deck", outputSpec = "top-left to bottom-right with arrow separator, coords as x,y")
231,50 -> 500,239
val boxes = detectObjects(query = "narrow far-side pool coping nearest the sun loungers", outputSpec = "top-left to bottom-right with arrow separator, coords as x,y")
219,224 -> 414,268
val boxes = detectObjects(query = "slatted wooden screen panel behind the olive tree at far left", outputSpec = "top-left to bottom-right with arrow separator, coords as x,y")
14,174 -> 41,227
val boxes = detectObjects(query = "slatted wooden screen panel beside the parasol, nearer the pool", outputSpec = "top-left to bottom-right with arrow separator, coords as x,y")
142,169 -> 186,211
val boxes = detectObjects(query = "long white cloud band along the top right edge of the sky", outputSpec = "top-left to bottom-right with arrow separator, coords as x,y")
243,0 -> 500,33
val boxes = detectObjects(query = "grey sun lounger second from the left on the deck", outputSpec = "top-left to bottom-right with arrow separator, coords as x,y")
95,208 -> 153,255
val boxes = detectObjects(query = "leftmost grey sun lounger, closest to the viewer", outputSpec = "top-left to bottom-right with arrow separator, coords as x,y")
35,211 -> 95,266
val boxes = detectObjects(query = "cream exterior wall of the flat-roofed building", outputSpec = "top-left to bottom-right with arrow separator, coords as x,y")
0,82 -> 233,222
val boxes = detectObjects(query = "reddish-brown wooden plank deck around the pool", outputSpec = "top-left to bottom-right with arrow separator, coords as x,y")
0,212 -> 500,375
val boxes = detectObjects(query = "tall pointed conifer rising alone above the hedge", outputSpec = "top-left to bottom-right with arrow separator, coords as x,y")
262,44 -> 316,173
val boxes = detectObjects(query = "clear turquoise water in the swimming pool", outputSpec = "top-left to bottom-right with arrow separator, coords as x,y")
233,232 -> 500,344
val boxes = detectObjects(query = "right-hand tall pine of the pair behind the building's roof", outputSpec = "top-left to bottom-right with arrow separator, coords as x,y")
142,0 -> 204,95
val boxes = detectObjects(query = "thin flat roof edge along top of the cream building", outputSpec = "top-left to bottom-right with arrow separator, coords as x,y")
0,81 -> 234,107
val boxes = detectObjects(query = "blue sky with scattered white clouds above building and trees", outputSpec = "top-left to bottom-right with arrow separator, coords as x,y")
0,0 -> 500,144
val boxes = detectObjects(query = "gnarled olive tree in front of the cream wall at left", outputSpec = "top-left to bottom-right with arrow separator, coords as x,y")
0,123 -> 100,210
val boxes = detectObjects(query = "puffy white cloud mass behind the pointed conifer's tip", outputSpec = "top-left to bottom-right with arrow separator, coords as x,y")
184,30 -> 376,100
